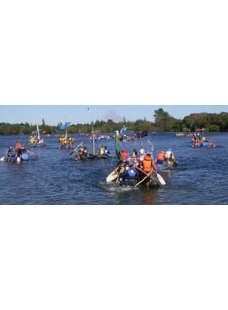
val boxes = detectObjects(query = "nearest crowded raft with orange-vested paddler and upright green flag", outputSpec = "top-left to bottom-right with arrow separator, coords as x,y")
106,131 -> 166,188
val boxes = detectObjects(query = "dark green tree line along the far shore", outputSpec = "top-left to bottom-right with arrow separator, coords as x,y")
0,108 -> 228,135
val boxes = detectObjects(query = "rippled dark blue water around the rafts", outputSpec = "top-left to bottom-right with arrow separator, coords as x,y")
0,133 -> 228,205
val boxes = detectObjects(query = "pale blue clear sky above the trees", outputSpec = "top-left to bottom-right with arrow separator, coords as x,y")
0,105 -> 228,125
